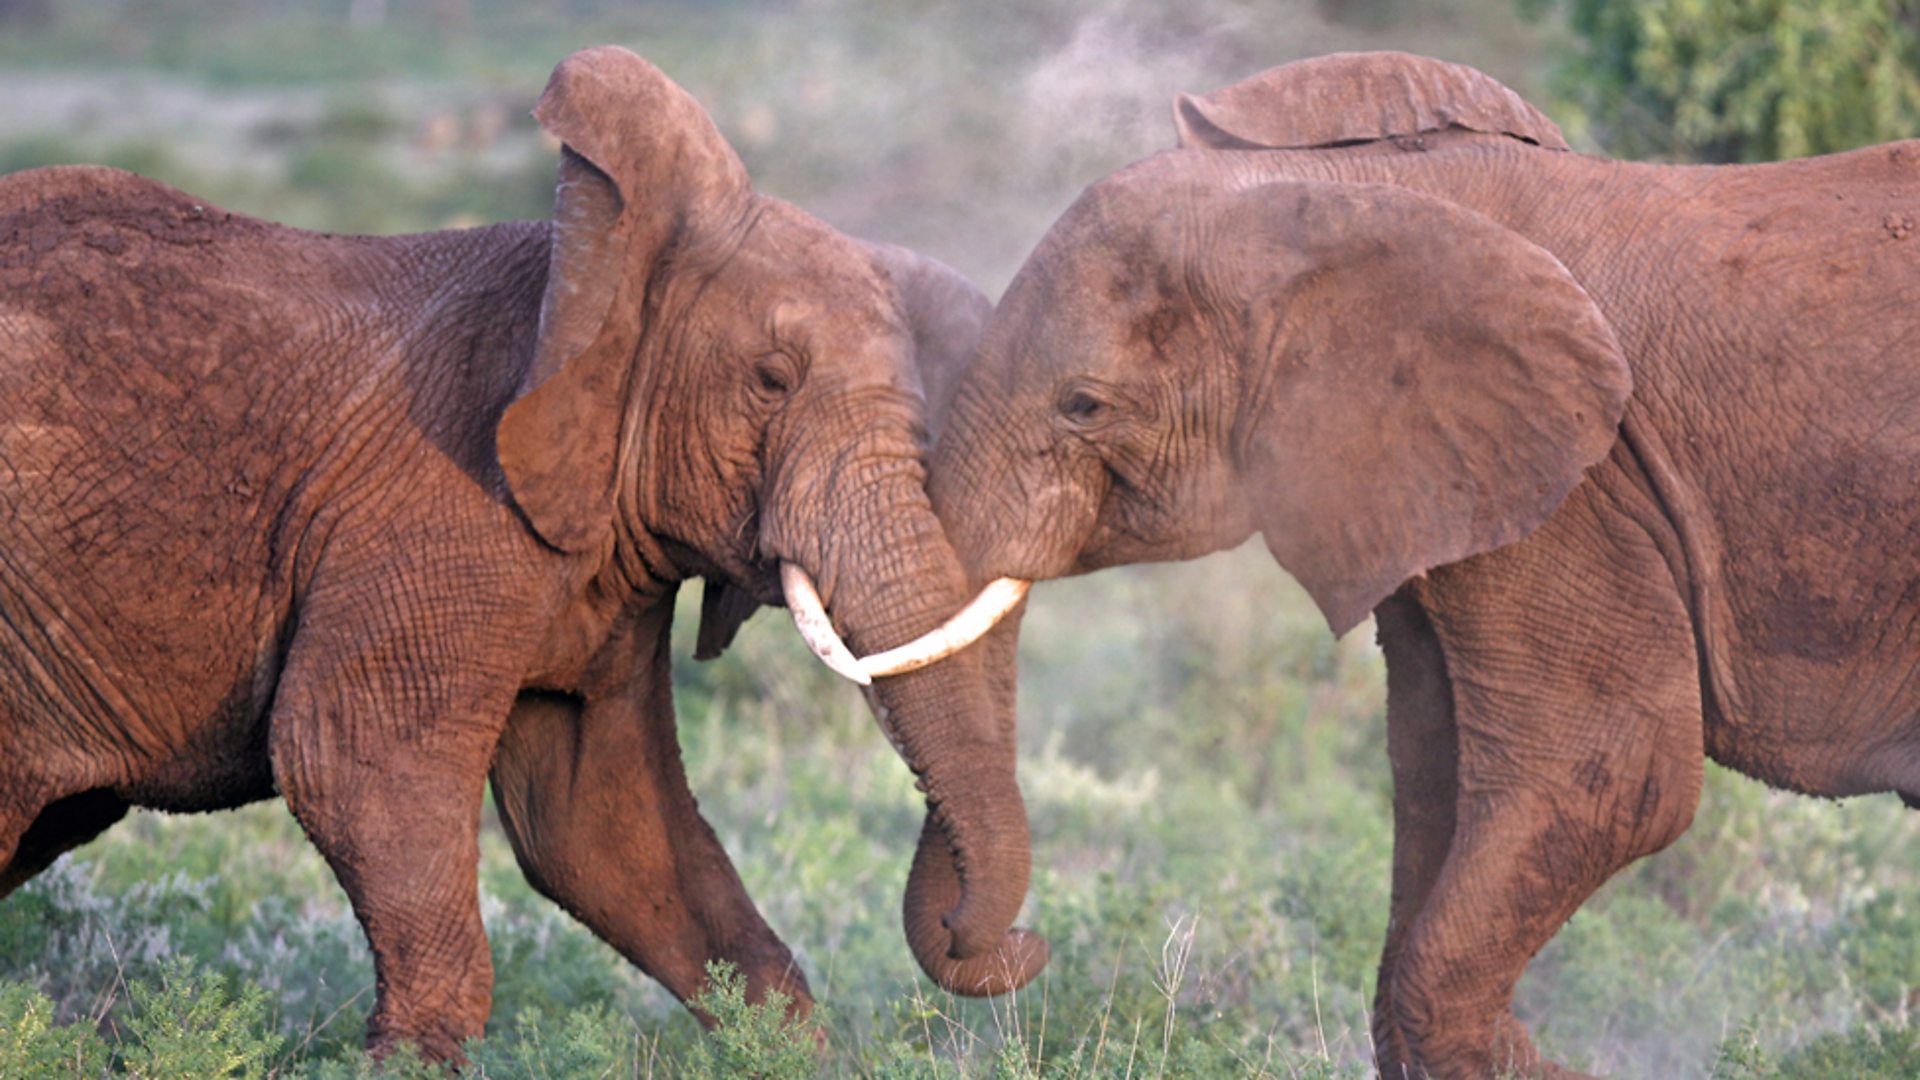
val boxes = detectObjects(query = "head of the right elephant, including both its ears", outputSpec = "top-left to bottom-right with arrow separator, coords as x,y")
902,54 -> 1630,680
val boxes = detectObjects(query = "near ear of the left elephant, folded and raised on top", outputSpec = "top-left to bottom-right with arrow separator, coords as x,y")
493,46 -> 753,552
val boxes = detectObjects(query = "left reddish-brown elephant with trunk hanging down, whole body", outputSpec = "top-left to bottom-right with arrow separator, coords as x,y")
0,48 -> 1044,1057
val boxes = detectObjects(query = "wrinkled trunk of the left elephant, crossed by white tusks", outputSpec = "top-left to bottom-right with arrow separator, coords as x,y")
781,434 -> 1046,995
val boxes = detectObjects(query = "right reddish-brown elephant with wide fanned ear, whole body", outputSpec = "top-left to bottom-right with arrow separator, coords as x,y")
929,54 -> 1920,1076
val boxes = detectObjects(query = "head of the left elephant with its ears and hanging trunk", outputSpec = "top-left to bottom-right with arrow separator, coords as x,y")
493,48 -> 1046,994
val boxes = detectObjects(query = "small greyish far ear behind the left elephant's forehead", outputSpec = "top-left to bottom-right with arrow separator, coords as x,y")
868,244 -> 993,440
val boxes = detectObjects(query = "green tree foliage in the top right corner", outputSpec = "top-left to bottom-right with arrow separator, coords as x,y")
1521,0 -> 1920,161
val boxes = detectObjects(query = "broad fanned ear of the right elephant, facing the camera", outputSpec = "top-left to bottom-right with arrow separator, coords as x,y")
1213,181 -> 1632,634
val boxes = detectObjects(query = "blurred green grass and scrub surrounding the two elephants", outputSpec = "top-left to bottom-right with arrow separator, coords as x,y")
0,0 -> 1920,1076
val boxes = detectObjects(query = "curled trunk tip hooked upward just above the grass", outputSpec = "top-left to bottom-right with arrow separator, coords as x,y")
902,813 -> 1052,997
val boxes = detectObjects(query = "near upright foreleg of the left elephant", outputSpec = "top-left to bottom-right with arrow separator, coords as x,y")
269,564 -> 532,1061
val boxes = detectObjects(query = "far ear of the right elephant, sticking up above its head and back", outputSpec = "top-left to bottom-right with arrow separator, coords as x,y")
1173,52 -> 1567,150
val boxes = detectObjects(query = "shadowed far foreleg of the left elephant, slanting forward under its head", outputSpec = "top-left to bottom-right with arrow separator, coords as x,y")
493,611 -> 812,1019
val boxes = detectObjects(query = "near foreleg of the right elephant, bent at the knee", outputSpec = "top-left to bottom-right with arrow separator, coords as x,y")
1377,496 -> 1703,1078
